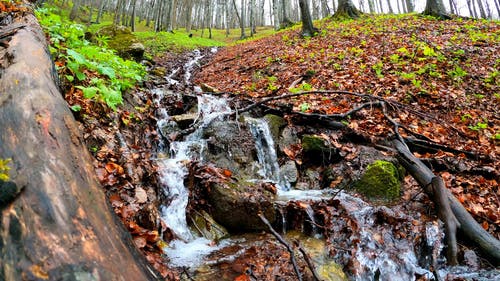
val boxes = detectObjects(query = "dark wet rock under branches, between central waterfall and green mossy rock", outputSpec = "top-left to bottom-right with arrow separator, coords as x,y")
302,135 -> 340,164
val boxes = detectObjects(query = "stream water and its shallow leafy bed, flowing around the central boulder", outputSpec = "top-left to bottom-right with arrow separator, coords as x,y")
148,49 -> 500,281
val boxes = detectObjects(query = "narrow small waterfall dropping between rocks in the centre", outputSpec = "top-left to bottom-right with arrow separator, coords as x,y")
245,117 -> 290,191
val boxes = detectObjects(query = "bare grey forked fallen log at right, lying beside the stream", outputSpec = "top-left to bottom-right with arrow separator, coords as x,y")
392,140 -> 500,265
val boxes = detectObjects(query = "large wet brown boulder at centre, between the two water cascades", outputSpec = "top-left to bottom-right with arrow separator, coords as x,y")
209,181 -> 276,232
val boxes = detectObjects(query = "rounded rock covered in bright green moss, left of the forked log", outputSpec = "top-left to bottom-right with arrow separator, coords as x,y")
354,160 -> 403,203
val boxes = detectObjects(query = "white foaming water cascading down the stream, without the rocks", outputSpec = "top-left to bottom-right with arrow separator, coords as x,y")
149,49 -> 500,281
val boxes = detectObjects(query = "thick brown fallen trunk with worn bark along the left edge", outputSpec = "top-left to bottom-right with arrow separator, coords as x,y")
0,14 -> 155,280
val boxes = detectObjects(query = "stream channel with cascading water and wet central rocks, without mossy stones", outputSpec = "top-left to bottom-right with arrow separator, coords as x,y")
146,49 -> 498,281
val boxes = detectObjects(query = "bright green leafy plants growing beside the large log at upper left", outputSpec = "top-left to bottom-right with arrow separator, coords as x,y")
36,5 -> 146,111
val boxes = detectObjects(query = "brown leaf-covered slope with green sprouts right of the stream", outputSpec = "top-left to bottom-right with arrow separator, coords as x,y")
196,15 -> 500,238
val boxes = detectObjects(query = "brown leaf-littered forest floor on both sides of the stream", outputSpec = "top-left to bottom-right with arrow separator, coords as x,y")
20,1 -> 500,279
